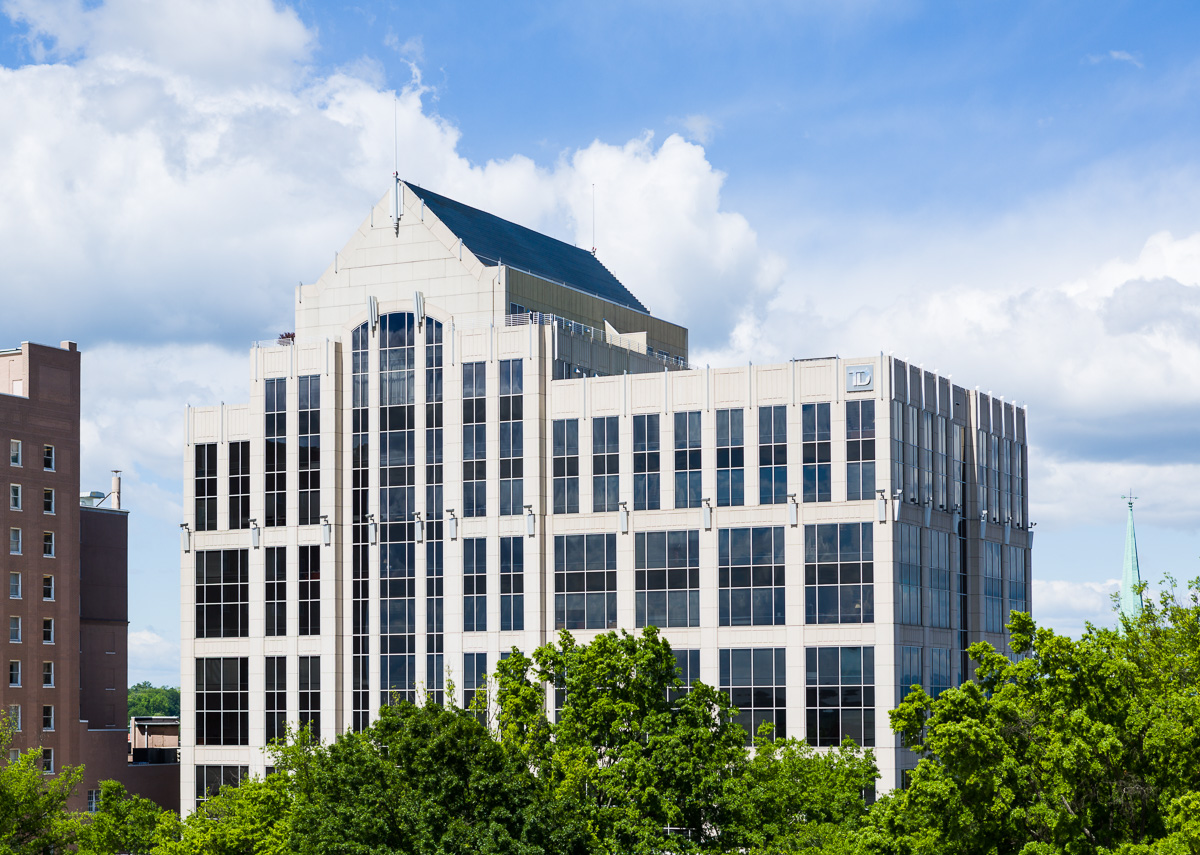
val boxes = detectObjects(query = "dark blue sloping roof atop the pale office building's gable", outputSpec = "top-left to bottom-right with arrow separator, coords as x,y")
406,184 -> 649,313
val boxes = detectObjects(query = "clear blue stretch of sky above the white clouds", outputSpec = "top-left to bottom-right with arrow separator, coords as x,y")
292,2 -> 1200,219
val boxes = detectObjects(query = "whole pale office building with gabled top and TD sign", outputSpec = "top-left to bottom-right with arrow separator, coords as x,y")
181,183 -> 1031,808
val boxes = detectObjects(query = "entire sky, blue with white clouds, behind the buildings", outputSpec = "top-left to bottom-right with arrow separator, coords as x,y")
0,0 -> 1200,682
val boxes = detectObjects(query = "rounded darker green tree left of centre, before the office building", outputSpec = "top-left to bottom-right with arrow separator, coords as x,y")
272,702 -> 587,855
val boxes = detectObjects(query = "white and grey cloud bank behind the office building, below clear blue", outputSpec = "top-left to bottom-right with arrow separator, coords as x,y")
0,0 -> 1200,677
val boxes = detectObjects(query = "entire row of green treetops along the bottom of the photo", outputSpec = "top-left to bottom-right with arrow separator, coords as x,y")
14,598 -> 1200,855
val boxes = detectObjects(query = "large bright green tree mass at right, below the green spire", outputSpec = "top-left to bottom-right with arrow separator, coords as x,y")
860,580 -> 1200,855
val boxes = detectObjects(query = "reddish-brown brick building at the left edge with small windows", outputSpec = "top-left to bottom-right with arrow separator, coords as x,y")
0,341 -> 179,809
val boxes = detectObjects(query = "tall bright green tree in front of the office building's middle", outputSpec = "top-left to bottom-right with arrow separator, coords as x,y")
497,627 -> 876,853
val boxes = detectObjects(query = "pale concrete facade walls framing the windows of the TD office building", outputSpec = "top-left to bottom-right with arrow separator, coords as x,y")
180,185 -> 1032,809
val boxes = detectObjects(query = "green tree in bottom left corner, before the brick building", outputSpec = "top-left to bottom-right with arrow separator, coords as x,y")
0,719 -> 83,855
